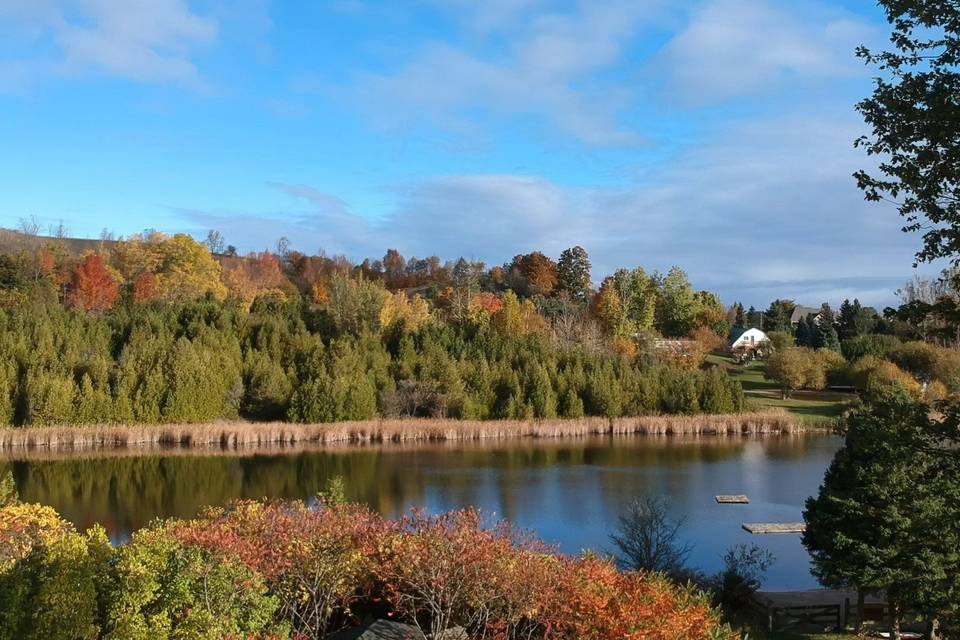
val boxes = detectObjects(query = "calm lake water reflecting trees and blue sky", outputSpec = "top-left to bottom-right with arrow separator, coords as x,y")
0,435 -> 840,590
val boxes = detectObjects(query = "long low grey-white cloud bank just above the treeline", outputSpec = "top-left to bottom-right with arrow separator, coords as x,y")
176,109 -> 918,305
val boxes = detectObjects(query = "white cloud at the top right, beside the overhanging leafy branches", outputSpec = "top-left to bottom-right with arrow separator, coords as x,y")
654,0 -> 874,105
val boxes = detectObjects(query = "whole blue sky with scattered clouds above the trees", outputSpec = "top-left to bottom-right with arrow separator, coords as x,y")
0,0 -> 935,306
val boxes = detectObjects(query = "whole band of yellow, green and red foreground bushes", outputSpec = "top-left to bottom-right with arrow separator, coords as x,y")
0,501 -> 729,640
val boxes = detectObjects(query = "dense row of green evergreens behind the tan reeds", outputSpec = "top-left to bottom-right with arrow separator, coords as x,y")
0,297 -> 743,425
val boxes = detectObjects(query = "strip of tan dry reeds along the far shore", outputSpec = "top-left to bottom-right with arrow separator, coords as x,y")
0,411 -> 817,452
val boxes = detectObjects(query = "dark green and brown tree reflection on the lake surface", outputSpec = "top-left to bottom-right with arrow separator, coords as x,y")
0,437 -> 824,537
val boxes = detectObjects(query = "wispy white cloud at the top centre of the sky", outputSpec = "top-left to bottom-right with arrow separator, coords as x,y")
352,0 -> 654,146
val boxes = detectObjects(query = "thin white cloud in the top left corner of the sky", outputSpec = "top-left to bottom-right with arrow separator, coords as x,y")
0,0 -> 217,87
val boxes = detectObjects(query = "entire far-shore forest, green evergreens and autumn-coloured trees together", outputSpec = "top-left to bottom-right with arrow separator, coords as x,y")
0,232 -> 744,426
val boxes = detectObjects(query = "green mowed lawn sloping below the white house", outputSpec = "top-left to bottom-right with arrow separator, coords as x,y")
707,353 -> 856,423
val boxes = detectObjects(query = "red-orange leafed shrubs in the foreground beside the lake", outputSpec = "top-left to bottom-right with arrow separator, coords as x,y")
172,502 -> 733,640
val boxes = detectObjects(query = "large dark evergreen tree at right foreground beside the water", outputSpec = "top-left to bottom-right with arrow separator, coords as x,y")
803,390 -> 960,637
